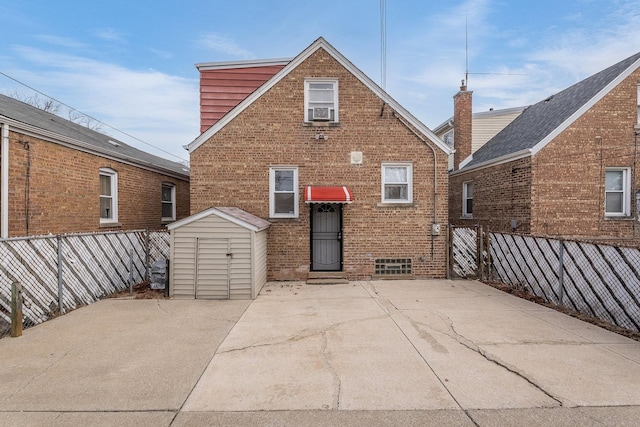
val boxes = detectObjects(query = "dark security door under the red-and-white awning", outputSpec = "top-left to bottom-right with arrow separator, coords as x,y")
311,203 -> 342,271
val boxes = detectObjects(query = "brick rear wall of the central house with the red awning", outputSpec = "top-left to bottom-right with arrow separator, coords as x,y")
191,50 -> 448,280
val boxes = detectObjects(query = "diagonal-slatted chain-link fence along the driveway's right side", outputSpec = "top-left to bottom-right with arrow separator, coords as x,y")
451,228 -> 640,331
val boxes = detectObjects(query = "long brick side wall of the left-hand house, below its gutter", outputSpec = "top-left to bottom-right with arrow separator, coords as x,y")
0,131 -> 189,237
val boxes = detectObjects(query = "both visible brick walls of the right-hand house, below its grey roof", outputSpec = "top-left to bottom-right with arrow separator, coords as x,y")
449,66 -> 640,243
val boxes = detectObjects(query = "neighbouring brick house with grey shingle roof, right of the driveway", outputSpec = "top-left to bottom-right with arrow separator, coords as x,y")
449,53 -> 640,243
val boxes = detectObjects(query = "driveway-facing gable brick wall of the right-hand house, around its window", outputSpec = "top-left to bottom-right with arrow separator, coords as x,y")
532,67 -> 640,244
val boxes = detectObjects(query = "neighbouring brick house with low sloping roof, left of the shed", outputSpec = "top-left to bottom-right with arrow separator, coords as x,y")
0,95 -> 189,238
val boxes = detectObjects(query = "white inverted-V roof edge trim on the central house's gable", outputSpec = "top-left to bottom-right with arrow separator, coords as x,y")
186,37 -> 451,154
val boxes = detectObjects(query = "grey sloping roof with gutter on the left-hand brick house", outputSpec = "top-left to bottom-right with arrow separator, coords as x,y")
0,95 -> 189,179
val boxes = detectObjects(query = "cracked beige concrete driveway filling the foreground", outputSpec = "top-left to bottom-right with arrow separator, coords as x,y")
0,280 -> 640,426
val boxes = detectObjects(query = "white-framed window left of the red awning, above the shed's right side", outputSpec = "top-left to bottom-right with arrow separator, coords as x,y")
269,166 -> 298,218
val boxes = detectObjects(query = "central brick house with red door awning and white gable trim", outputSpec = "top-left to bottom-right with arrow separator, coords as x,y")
188,38 -> 450,280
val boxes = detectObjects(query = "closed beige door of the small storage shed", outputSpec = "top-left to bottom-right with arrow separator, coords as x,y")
195,238 -> 231,299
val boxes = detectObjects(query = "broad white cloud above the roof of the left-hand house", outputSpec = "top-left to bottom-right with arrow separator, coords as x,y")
7,47 -> 199,161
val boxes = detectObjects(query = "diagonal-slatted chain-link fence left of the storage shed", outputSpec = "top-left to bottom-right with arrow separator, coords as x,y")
0,230 -> 169,338
